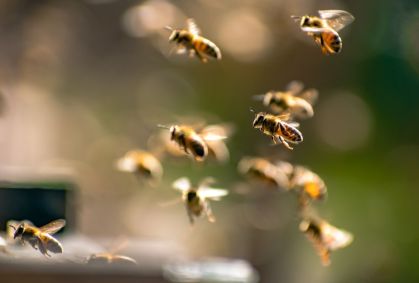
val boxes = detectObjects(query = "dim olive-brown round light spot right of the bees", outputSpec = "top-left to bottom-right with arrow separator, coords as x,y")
315,92 -> 372,151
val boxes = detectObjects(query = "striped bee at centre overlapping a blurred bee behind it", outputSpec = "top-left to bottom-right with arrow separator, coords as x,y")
159,125 -> 228,161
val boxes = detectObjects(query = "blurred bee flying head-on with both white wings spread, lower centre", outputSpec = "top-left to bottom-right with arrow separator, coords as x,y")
172,177 -> 228,224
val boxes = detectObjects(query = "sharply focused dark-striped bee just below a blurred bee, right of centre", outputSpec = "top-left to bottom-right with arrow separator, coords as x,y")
253,112 -> 303,150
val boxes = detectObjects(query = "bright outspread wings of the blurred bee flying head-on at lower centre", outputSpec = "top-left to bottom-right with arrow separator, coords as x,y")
172,177 -> 228,200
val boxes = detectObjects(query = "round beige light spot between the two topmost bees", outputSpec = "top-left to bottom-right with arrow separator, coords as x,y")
217,9 -> 272,62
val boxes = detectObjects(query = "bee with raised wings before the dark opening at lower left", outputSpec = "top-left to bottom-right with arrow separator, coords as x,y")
10,219 -> 65,256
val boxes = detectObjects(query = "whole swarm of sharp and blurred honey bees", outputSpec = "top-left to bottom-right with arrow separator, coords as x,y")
2,10 -> 354,265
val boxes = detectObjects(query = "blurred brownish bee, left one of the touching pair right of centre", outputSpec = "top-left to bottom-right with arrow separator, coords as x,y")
238,157 -> 289,189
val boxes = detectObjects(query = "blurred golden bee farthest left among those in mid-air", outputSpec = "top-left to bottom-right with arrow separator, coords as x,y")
116,150 -> 163,184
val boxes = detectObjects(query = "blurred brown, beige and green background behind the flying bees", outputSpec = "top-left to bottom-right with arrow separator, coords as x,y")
0,0 -> 419,283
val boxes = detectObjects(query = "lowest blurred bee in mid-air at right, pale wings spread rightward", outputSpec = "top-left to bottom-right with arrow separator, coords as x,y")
300,217 -> 353,266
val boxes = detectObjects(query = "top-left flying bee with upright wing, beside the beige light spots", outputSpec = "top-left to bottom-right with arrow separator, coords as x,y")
166,19 -> 221,63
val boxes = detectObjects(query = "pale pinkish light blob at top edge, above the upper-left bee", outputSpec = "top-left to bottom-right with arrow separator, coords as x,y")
122,0 -> 181,37
